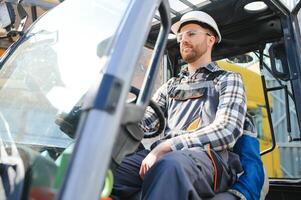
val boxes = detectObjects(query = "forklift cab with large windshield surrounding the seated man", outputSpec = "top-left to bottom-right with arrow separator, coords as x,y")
0,0 -> 301,200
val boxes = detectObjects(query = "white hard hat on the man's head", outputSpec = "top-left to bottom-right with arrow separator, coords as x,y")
171,11 -> 222,43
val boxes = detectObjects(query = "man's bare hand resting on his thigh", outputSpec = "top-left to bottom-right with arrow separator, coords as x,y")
139,141 -> 171,179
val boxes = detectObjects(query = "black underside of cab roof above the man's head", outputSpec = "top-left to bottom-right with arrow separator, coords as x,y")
147,0 -> 290,59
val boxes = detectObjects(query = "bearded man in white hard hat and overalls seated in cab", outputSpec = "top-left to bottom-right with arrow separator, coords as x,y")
113,11 -> 263,200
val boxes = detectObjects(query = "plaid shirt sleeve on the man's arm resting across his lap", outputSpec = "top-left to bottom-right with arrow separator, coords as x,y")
169,73 -> 247,150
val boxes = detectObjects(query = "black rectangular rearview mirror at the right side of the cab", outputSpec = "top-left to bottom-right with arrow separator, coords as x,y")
269,42 -> 290,81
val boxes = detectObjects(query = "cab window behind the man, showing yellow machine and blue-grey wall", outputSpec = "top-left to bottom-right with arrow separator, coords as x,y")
217,48 -> 301,178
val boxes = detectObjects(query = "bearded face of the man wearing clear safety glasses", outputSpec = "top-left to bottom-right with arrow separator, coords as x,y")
178,24 -> 213,63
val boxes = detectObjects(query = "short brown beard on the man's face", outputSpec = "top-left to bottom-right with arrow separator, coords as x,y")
180,44 -> 207,63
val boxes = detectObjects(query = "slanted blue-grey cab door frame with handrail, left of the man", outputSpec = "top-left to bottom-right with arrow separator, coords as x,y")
58,0 -> 170,199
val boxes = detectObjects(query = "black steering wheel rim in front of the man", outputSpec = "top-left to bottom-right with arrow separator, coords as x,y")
130,86 -> 166,138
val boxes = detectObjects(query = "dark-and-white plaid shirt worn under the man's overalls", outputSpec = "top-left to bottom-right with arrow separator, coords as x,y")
140,62 -> 247,151
